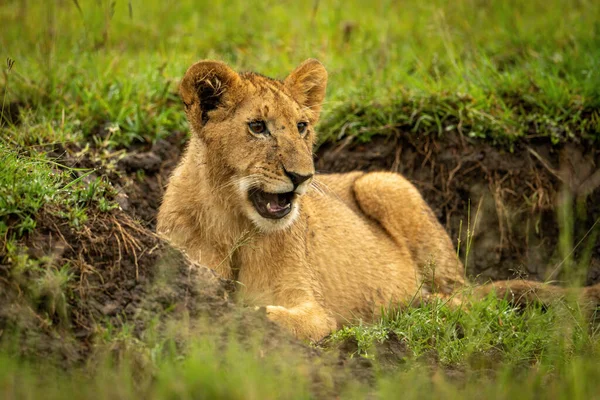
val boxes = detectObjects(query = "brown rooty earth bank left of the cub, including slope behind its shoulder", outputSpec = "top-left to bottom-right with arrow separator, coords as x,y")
0,135 -> 247,366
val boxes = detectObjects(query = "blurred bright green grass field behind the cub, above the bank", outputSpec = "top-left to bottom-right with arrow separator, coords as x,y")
0,0 -> 600,145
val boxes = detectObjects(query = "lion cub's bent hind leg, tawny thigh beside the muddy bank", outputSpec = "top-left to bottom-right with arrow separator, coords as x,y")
354,172 -> 464,294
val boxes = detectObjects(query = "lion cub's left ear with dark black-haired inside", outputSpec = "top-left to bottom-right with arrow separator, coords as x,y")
179,60 -> 241,130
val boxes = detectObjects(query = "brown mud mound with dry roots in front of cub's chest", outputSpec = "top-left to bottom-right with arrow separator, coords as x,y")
0,206 -> 233,366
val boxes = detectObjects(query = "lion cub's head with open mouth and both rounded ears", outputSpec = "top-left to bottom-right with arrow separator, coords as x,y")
180,59 -> 327,231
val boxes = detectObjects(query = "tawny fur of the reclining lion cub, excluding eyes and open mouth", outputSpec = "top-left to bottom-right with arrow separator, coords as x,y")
158,60 -> 597,340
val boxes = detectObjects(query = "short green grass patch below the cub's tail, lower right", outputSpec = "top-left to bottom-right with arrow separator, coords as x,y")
328,296 -> 600,367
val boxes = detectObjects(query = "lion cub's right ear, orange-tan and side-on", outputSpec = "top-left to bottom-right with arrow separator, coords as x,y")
284,58 -> 327,123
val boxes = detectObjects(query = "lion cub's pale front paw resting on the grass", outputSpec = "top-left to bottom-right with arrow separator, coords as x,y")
266,302 -> 337,341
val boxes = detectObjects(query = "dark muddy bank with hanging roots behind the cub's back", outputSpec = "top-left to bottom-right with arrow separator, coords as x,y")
316,133 -> 600,285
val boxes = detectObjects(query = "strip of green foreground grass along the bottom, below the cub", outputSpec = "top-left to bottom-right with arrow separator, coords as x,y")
0,296 -> 600,399
